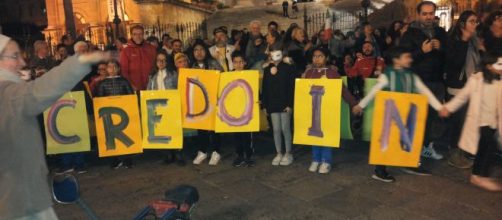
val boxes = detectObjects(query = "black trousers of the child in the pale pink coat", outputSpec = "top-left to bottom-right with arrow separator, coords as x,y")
472,127 -> 498,177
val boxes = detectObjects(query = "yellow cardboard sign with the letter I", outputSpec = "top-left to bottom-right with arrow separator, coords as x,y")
293,79 -> 342,147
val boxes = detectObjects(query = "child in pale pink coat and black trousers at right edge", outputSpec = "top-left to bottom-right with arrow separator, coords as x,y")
440,54 -> 502,191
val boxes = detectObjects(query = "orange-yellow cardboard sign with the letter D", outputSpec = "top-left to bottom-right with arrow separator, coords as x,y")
178,69 -> 220,130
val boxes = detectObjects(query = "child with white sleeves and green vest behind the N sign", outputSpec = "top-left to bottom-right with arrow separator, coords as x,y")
352,47 -> 442,182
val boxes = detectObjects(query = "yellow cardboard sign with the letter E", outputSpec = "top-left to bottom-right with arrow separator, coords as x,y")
141,90 -> 183,149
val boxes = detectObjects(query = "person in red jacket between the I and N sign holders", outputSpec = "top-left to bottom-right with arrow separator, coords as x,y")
345,41 -> 385,79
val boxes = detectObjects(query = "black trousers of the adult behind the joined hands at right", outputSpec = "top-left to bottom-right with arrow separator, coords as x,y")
446,93 -> 469,149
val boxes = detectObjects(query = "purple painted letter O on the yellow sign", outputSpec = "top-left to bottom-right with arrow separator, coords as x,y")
218,79 -> 254,126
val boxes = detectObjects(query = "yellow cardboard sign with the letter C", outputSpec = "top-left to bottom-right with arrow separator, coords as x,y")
44,91 -> 91,154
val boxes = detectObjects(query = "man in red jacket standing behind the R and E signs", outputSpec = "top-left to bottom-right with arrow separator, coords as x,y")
120,25 -> 156,91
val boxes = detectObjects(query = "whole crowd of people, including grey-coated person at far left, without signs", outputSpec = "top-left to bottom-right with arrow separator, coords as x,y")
0,1 -> 502,218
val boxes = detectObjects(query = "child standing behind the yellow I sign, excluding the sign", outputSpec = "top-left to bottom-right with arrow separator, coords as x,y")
302,47 -> 357,174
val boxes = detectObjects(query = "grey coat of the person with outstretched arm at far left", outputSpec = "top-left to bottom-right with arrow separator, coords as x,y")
0,56 -> 91,219
